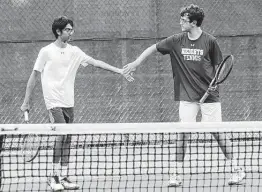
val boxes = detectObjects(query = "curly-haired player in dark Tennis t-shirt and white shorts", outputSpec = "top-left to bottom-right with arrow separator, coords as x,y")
124,4 -> 246,187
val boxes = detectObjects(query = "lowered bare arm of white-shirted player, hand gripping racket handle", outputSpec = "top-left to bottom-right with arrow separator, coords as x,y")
21,70 -> 41,111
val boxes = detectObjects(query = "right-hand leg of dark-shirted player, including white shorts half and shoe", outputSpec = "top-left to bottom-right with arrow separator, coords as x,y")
201,103 -> 246,185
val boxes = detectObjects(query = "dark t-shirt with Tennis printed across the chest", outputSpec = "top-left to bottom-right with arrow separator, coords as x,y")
156,32 -> 223,103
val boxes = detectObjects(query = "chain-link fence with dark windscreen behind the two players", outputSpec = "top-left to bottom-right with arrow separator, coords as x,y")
0,0 -> 262,123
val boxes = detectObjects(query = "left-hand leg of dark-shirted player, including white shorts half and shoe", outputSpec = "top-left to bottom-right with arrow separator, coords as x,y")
169,101 -> 199,187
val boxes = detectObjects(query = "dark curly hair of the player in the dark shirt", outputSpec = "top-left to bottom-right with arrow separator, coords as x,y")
180,4 -> 205,27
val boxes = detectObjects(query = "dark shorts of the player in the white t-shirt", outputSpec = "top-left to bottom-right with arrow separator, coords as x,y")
48,107 -> 74,123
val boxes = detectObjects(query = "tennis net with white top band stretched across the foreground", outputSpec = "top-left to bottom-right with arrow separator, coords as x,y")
0,122 -> 262,192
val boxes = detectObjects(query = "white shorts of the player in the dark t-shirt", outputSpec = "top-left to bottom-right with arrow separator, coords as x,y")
179,101 -> 222,122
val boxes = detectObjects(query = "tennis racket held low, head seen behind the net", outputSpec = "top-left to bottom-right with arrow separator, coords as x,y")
21,111 -> 40,162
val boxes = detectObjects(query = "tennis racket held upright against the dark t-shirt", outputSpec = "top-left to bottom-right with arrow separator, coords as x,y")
199,55 -> 234,103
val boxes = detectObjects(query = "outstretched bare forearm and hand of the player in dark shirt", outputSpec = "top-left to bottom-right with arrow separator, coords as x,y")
124,44 -> 157,74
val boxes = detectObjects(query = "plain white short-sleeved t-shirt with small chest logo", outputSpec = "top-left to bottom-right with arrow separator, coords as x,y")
34,43 -> 92,110
